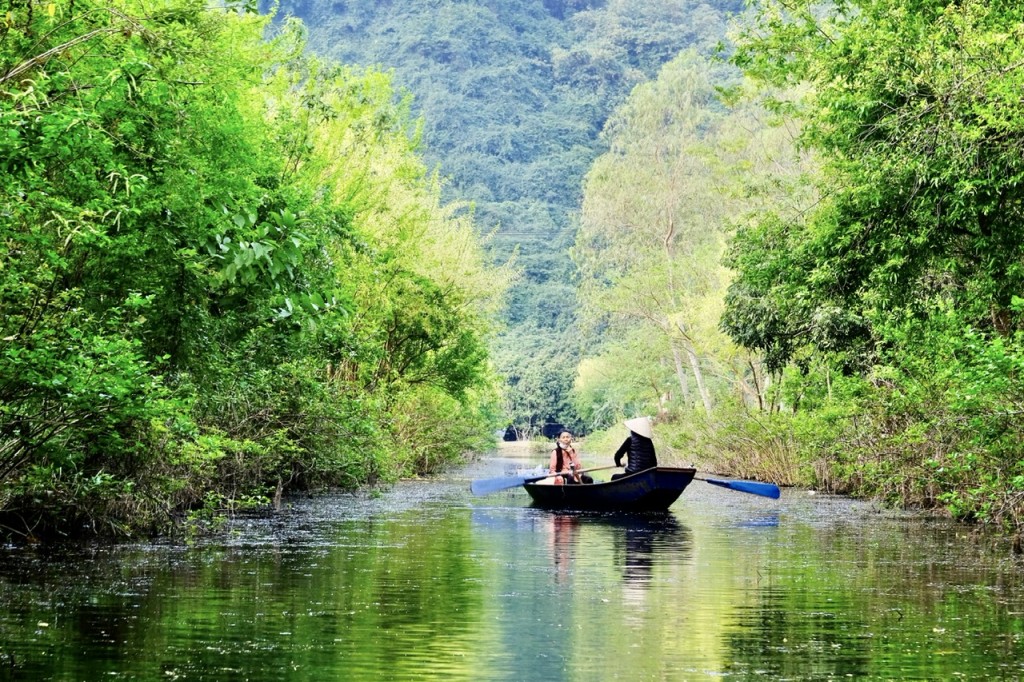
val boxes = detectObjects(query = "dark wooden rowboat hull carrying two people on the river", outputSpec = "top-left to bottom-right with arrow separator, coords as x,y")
523,467 -> 697,511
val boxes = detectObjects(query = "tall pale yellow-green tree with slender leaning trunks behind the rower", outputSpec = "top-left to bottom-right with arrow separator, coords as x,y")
578,54 -> 724,412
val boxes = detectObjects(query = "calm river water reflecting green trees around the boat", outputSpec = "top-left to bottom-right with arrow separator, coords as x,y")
0,448 -> 1024,680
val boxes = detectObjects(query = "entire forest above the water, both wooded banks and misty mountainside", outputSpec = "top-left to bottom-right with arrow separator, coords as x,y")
6,0 -> 1024,548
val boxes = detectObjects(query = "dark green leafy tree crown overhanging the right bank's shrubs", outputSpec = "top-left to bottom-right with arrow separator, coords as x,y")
737,1 -> 1021,364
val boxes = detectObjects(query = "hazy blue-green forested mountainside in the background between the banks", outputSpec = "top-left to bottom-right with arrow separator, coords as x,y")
261,0 -> 743,430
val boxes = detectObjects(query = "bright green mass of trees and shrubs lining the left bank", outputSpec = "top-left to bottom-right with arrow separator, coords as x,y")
0,0 -> 507,535
